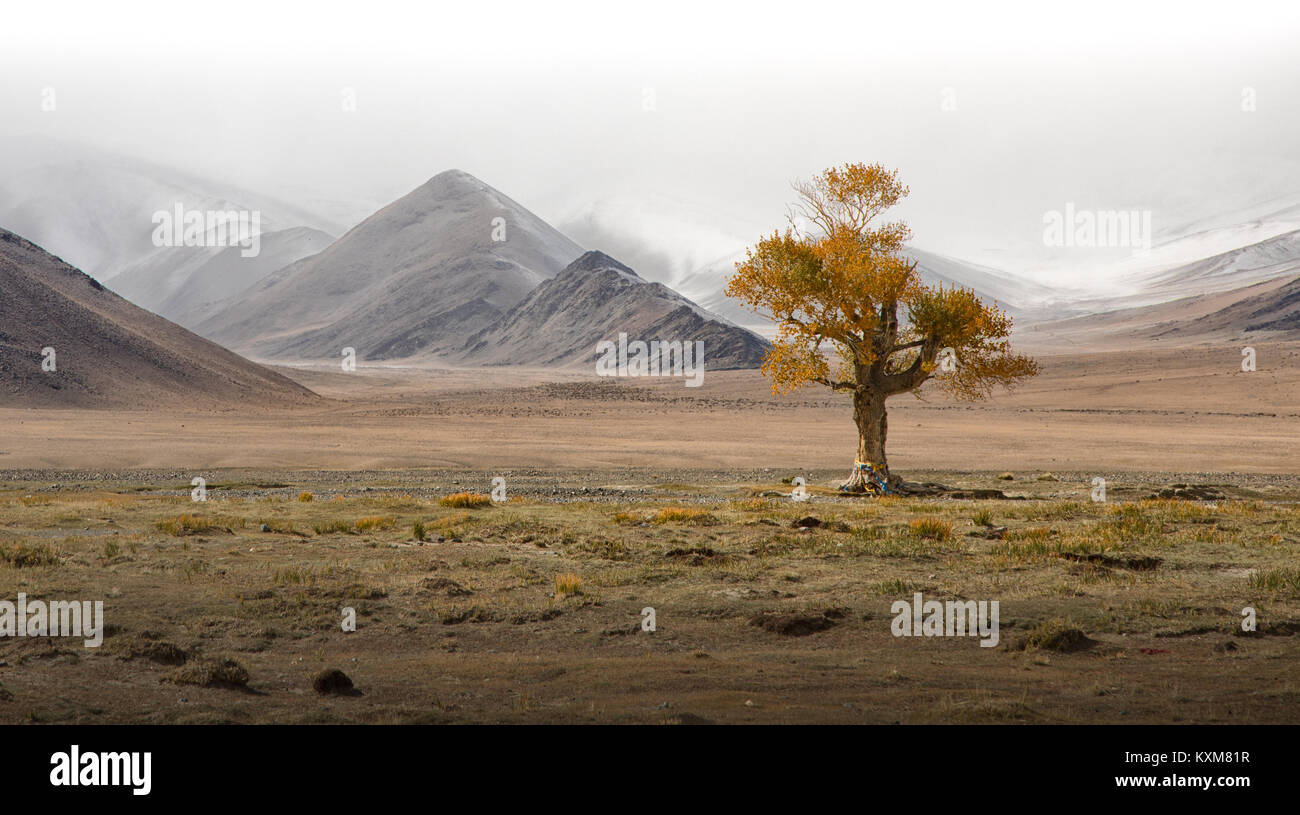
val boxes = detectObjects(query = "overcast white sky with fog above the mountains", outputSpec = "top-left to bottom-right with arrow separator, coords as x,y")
0,0 -> 1300,288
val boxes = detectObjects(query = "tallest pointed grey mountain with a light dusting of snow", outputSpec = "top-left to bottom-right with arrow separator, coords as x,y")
196,170 -> 582,359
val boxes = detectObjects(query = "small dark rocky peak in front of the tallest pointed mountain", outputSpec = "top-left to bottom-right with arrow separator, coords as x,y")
458,252 -> 767,370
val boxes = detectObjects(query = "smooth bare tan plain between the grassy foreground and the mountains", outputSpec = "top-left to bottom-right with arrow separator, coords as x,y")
0,343 -> 1300,474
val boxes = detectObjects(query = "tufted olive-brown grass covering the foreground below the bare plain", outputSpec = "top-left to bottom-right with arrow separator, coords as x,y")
0,474 -> 1300,723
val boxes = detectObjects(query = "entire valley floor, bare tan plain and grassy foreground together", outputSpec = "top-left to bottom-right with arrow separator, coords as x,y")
0,346 -> 1300,724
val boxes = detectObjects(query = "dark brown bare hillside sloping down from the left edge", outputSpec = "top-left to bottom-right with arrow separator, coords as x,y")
0,229 -> 317,409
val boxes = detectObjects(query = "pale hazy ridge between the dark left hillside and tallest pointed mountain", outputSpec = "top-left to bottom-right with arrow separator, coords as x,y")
108,226 -> 334,328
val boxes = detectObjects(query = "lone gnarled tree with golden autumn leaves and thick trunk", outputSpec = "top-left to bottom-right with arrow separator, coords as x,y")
727,164 -> 1037,493
